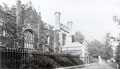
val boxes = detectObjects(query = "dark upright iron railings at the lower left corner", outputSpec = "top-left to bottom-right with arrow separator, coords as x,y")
0,47 -> 29,69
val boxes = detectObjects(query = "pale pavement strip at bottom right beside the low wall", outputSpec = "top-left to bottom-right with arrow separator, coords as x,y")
75,63 -> 116,69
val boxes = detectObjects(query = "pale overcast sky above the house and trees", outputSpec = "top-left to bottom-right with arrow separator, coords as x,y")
0,0 -> 120,40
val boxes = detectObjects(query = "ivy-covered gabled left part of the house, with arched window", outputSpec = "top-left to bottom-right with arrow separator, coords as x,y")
0,0 -> 54,49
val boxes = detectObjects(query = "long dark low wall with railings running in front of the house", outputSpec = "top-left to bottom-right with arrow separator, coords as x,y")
0,47 -> 83,69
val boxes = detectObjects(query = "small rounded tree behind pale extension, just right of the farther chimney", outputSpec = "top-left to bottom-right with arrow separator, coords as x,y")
73,31 -> 85,43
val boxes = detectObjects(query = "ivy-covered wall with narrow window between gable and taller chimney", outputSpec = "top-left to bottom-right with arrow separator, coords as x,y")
40,23 -> 54,52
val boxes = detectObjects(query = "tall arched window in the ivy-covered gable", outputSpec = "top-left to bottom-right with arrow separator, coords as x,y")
24,29 -> 35,49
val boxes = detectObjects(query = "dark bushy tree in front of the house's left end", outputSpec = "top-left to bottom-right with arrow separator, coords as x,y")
0,19 -> 24,48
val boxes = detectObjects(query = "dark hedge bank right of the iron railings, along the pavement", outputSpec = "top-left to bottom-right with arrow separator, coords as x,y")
23,54 -> 83,68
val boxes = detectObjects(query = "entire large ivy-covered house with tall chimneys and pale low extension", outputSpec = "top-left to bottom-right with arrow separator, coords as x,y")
0,0 -> 86,55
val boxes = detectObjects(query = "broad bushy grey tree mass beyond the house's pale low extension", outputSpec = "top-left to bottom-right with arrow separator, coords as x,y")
88,40 -> 113,59
